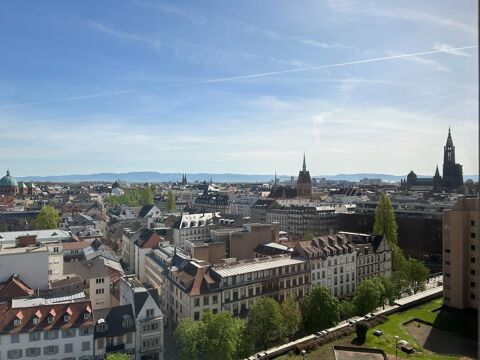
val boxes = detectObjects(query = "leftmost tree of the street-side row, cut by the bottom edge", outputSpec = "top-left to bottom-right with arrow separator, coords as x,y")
175,318 -> 205,360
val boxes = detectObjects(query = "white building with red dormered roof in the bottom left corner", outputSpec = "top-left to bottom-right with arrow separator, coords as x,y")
0,298 -> 94,360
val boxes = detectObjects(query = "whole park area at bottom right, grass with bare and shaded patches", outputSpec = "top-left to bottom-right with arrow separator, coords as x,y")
279,298 -> 478,360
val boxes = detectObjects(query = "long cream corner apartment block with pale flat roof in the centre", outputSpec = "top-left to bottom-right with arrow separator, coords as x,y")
146,249 -> 310,328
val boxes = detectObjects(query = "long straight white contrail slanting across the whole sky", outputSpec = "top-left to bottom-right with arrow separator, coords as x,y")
0,45 -> 478,110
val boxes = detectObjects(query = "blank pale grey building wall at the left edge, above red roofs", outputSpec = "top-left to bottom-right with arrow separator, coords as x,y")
0,248 -> 49,289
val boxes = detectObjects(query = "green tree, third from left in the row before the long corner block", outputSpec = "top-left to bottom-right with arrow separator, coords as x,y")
247,297 -> 285,350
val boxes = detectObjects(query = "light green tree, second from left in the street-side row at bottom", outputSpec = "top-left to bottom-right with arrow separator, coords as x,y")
201,311 -> 246,360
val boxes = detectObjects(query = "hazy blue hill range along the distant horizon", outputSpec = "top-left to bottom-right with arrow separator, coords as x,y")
18,171 -> 478,183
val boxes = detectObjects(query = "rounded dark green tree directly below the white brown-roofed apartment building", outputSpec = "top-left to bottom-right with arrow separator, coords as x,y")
301,285 -> 340,332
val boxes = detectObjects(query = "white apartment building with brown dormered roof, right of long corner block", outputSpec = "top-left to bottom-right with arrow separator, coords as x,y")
294,234 -> 357,298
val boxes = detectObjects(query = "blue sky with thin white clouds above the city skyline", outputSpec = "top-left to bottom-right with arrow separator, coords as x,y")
0,0 -> 478,176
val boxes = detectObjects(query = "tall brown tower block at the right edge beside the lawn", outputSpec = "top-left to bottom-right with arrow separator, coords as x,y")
443,198 -> 480,309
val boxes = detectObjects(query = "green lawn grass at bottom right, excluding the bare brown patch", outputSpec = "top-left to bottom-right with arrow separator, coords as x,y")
280,298 -> 476,360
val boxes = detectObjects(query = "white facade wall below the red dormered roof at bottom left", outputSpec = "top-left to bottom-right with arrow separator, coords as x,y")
0,326 -> 93,360
